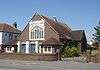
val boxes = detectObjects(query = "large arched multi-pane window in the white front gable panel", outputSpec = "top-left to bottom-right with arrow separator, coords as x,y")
31,26 -> 44,39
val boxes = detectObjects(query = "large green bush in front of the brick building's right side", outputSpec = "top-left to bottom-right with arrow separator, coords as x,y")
61,41 -> 79,57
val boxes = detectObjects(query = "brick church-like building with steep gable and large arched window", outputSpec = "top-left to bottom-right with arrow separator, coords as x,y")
17,13 -> 87,54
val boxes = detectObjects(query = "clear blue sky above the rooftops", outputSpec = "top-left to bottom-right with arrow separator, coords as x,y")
0,0 -> 100,41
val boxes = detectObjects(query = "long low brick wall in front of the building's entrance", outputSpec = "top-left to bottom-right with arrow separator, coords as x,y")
0,53 -> 58,61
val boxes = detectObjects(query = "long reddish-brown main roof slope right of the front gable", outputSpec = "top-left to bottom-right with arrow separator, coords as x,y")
42,15 -> 71,38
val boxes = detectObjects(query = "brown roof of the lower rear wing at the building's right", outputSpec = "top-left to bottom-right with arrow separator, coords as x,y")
71,30 -> 84,41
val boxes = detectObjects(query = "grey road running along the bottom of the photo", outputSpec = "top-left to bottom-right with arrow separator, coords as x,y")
0,59 -> 100,70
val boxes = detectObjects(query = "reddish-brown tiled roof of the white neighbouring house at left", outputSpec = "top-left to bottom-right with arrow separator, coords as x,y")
0,23 -> 21,33
